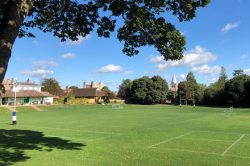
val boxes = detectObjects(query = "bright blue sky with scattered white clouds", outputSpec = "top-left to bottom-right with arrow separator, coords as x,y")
5,0 -> 250,91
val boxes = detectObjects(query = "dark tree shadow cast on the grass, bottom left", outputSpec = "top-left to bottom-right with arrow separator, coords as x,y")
0,129 -> 86,166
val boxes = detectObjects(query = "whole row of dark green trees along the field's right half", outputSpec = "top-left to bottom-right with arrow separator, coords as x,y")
118,67 -> 250,107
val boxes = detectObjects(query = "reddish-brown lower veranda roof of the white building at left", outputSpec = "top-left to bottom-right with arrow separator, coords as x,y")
1,90 -> 53,97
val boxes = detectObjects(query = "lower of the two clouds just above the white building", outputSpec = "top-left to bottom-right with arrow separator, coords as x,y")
21,69 -> 54,78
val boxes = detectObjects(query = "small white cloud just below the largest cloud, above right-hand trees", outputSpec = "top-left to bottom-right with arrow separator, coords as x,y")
192,65 -> 221,75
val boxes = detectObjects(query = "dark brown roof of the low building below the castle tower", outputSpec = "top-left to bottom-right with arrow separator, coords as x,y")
73,88 -> 107,97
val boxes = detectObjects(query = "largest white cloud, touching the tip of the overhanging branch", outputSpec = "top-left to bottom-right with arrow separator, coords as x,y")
149,46 -> 217,70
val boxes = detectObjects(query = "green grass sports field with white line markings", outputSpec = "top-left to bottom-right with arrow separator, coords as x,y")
0,105 -> 250,166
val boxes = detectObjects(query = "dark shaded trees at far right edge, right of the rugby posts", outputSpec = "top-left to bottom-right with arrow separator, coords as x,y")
203,68 -> 250,107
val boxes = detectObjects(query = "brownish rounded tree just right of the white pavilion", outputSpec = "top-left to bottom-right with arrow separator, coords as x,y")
42,78 -> 63,96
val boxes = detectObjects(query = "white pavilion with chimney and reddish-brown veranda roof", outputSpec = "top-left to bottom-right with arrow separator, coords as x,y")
0,79 -> 53,105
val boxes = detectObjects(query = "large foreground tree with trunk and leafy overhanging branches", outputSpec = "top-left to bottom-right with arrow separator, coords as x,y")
0,0 -> 210,83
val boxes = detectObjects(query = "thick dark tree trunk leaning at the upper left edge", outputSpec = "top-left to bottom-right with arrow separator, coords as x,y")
0,0 -> 33,83
